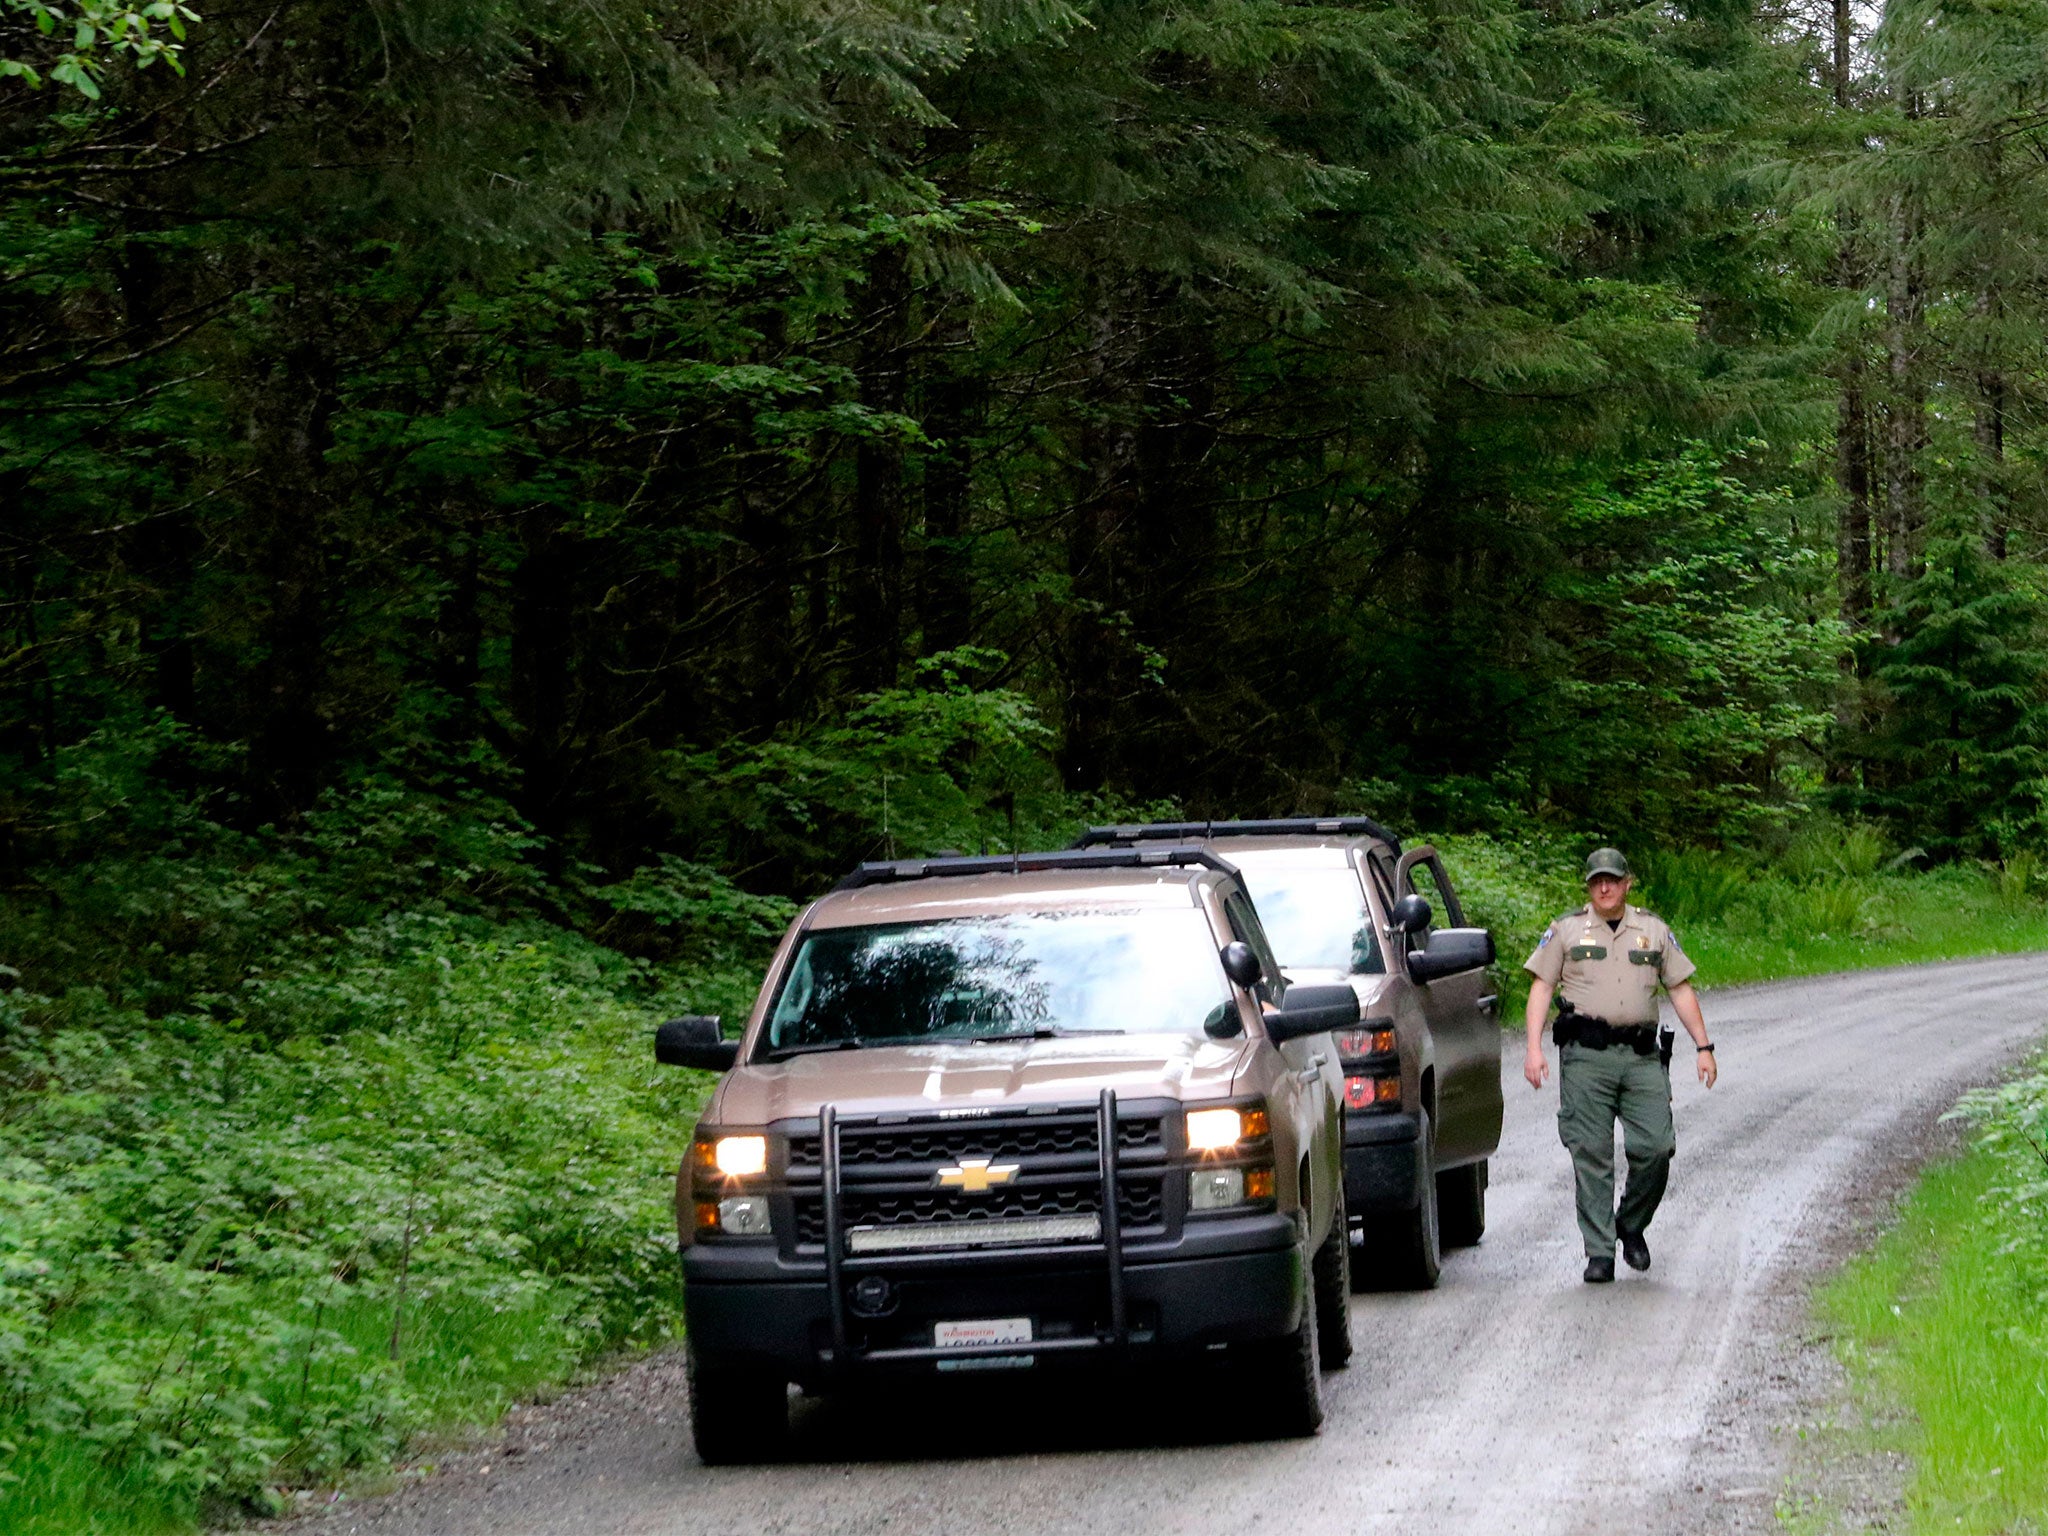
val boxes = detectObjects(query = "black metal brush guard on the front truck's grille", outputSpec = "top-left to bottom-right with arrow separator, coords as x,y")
819,1087 -> 1130,1372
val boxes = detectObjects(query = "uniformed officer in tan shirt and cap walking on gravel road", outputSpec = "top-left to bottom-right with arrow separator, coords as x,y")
1522,848 -> 1718,1284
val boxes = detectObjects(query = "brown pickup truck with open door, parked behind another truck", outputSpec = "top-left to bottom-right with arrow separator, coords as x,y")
1079,817 -> 1501,1288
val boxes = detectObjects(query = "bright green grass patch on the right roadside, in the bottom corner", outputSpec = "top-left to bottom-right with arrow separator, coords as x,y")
1819,1145 -> 2048,1536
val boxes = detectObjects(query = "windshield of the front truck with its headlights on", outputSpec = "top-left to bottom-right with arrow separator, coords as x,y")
768,907 -> 1231,1051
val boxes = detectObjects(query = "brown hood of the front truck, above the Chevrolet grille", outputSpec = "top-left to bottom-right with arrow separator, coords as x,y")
707,1034 -> 1255,1126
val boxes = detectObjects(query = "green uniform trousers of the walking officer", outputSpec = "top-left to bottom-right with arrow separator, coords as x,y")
1556,1044 -> 1677,1260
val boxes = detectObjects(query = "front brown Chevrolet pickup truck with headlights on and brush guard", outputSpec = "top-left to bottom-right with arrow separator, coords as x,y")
655,846 -> 1358,1462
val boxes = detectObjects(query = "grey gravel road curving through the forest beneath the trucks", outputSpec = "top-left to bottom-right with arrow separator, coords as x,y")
283,954 -> 2048,1536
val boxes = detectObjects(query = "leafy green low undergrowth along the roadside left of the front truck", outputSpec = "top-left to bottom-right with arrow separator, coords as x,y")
0,915 -> 724,1530
